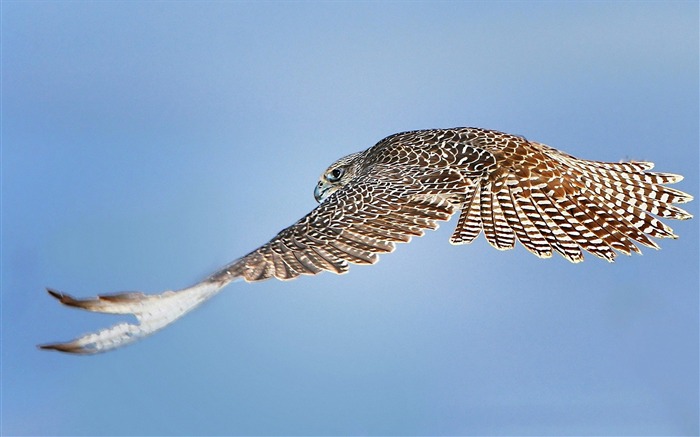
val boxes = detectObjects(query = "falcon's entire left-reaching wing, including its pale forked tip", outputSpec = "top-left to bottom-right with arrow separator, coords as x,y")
39,163 -> 468,354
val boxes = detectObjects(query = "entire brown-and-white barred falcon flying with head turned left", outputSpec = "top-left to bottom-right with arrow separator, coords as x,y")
39,128 -> 693,354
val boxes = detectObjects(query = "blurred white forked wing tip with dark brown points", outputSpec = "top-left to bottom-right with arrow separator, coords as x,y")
39,280 -> 227,355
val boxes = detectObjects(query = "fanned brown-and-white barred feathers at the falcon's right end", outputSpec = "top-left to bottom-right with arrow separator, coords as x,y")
450,134 -> 693,262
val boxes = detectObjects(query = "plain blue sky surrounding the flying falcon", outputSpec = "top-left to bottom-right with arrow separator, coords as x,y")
1,2 -> 700,435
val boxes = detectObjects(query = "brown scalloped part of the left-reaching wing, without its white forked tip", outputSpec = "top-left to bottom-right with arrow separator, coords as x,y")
215,169 -> 460,281
